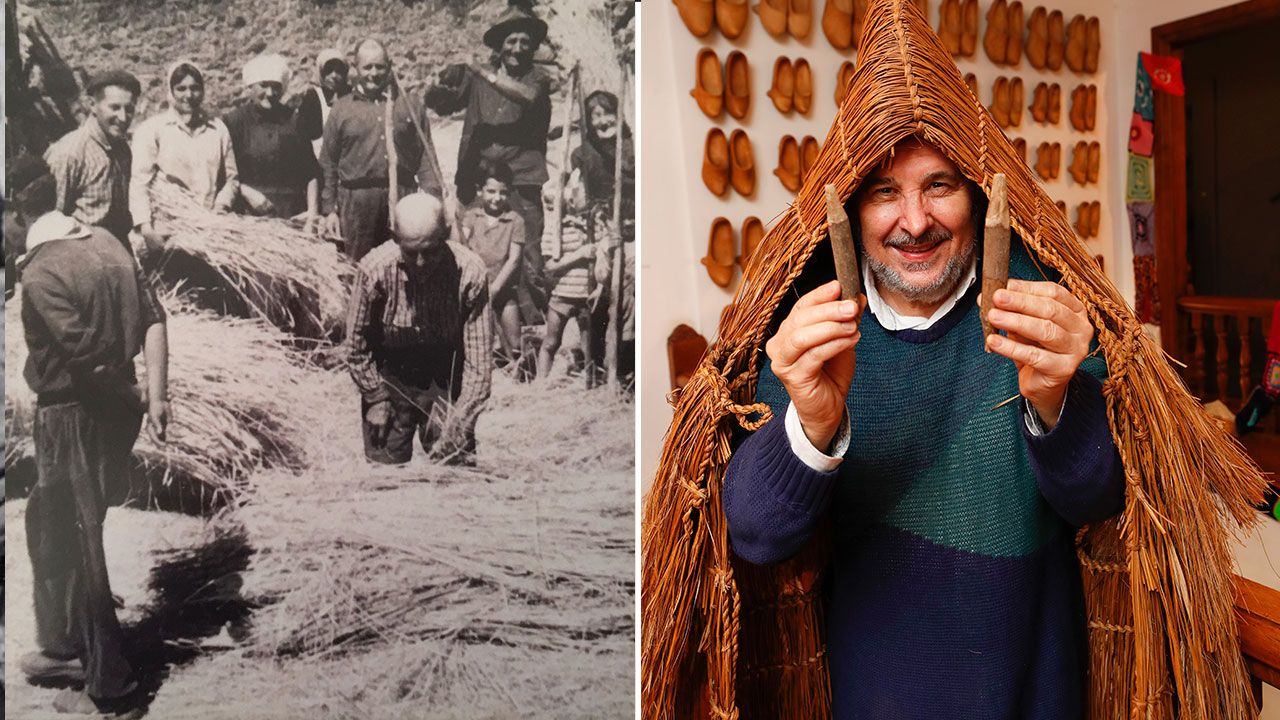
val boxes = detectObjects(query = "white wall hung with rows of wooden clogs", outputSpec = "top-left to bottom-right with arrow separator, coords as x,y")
639,0 -> 1229,488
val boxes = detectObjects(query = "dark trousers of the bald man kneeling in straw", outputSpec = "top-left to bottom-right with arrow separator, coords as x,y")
360,365 -> 476,465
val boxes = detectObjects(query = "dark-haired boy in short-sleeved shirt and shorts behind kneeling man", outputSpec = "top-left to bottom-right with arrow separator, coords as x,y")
462,160 -> 525,359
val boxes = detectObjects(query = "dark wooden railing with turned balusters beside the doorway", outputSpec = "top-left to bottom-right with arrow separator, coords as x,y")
1178,295 -> 1276,410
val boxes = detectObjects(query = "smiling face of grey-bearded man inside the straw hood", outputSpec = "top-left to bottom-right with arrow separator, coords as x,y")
858,140 -> 975,304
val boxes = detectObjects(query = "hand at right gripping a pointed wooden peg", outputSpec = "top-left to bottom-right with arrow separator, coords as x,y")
987,279 -> 1093,429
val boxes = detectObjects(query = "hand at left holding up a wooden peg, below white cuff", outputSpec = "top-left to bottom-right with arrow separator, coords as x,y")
764,281 -> 867,451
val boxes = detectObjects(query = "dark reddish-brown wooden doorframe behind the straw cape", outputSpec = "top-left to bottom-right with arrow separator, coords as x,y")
1151,0 -> 1280,359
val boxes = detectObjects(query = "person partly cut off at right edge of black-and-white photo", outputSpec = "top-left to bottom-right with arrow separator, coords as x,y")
570,90 -> 636,380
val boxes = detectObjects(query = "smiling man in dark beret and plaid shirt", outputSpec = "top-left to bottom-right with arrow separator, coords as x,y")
45,70 -> 142,245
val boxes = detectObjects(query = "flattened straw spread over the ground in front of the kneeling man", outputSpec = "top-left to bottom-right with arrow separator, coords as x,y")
239,378 -> 635,716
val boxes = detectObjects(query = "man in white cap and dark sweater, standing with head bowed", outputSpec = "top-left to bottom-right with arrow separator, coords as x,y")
9,158 -> 169,714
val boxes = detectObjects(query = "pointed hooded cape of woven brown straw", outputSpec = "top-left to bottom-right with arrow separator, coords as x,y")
641,0 -> 1263,720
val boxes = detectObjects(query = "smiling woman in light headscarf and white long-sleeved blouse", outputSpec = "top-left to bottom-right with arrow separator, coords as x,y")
129,60 -> 239,249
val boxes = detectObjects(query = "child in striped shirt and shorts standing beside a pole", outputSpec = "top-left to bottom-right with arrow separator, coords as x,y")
538,170 -> 595,378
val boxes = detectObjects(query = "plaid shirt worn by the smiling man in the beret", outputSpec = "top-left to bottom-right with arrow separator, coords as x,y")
45,117 -> 133,237
